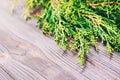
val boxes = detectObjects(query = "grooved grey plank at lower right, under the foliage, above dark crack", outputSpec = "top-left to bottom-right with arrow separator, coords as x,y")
87,49 -> 120,80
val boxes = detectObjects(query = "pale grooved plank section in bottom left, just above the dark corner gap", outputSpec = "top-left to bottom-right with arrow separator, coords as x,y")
2,60 -> 46,80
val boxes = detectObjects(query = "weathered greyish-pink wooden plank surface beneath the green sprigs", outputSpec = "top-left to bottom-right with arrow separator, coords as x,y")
0,0 -> 120,80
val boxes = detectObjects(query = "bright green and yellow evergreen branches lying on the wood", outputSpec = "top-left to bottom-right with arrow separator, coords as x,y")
26,0 -> 120,64
